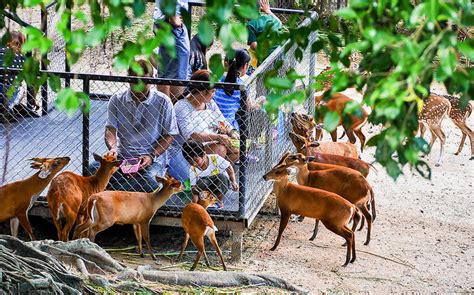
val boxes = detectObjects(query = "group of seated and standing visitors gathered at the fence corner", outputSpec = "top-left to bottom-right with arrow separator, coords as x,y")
91,0 -> 281,206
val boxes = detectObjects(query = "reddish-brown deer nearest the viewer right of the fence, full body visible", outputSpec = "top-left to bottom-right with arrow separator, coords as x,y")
263,155 -> 357,266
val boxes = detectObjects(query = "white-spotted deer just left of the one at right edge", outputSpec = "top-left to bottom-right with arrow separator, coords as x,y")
419,94 -> 451,166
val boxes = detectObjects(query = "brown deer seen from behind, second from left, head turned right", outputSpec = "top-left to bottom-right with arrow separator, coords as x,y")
46,153 -> 121,242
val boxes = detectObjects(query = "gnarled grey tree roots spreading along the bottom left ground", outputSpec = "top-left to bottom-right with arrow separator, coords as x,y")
0,235 -> 306,294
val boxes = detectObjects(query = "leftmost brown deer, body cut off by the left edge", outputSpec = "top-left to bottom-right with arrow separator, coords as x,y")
0,157 -> 71,240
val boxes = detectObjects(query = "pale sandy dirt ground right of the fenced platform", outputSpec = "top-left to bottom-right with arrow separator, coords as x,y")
233,86 -> 474,294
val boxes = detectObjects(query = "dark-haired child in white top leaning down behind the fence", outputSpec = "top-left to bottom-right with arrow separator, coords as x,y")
183,141 -> 239,208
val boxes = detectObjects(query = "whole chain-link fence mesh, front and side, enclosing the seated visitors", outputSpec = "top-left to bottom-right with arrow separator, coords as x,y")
0,5 -> 316,223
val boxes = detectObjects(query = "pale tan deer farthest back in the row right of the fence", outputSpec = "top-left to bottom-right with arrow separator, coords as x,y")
288,132 -> 359,159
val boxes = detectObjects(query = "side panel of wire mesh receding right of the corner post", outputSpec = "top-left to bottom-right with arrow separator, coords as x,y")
243,14 -> 317,218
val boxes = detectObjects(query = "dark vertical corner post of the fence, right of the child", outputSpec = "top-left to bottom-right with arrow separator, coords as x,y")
237,87 -> 249,217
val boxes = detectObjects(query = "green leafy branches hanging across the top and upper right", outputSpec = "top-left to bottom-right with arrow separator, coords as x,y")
0,0 -> 474,178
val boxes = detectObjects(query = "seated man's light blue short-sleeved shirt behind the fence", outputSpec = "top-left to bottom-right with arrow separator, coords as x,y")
106,88 -> 178,159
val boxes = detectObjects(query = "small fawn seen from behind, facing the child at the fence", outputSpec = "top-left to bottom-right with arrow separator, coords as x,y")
178,191 -> 227,270
